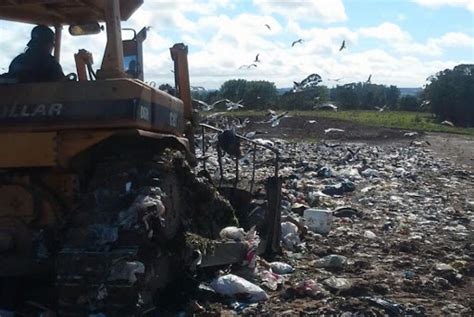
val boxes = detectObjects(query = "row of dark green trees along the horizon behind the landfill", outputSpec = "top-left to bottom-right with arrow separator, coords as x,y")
185,65 -> 474,126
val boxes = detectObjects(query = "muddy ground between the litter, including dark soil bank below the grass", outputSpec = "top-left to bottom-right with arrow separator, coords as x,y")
188,117 -> 474,316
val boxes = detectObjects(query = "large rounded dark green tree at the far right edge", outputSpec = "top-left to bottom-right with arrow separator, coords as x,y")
423,64 -> 474,126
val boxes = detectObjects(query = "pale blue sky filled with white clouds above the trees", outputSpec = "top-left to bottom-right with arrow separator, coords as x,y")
0,0 -> 474,88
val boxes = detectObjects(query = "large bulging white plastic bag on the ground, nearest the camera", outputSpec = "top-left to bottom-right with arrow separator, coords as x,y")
211,274 -> 268,302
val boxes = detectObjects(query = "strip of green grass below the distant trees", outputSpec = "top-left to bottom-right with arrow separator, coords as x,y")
223,110 -> 474,136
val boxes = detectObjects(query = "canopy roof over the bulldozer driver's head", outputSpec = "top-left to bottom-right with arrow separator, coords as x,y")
0,0 -> 143,25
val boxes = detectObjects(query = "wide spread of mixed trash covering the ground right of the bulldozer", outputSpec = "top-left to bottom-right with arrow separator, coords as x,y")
187,135 -> 474,316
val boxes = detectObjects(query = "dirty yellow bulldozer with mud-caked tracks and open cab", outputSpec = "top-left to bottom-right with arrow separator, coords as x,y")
0,0 -> 286,316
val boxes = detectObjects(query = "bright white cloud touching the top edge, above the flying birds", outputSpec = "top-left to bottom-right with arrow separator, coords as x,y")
253,0 -> 347,23
